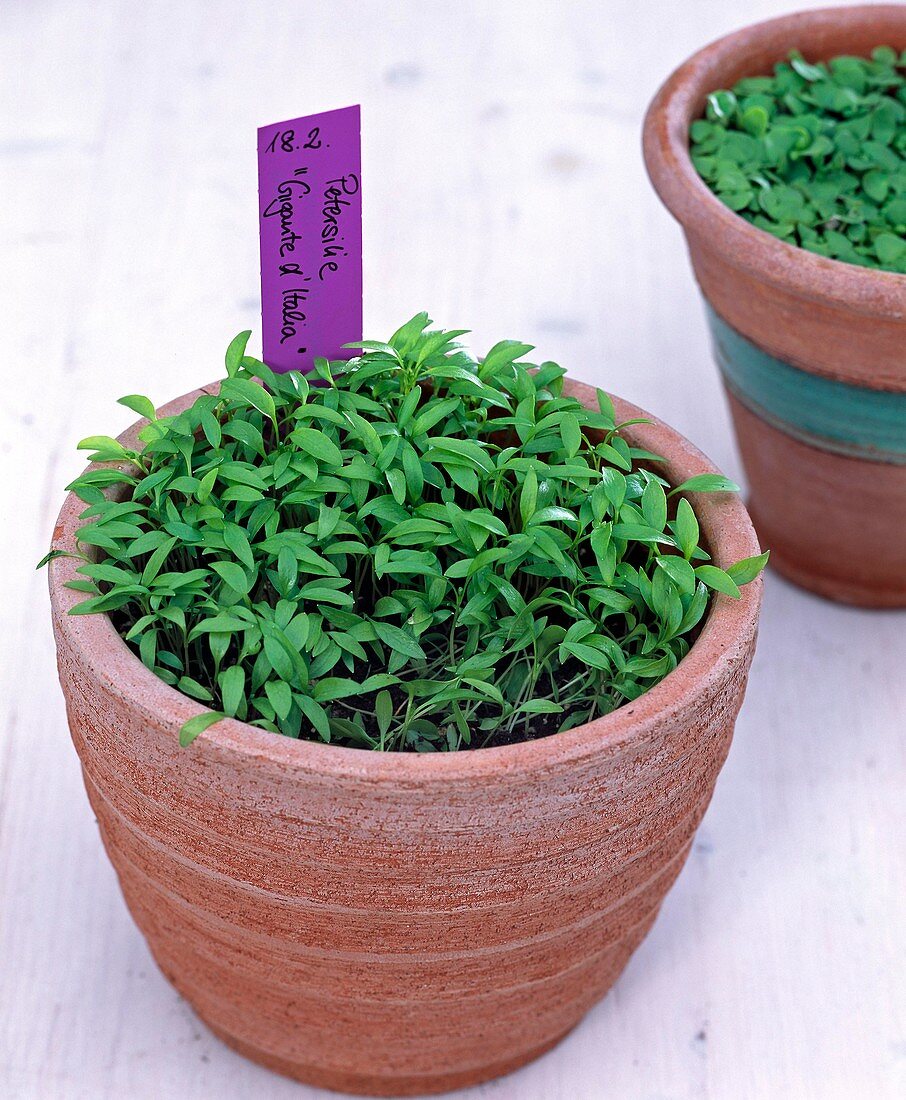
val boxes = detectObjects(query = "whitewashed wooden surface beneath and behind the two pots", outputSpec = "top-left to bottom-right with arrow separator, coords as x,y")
0,0 -> 906,1100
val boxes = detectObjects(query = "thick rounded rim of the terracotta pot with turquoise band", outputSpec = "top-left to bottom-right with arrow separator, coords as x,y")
642,4 -> 906,317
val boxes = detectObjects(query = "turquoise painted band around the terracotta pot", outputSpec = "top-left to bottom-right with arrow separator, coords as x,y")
706,306 -> 906,464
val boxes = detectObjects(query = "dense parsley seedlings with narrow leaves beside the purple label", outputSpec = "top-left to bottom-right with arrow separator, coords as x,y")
42,314 -> 766,750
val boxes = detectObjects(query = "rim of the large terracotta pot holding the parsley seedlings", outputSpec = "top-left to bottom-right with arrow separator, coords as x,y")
48,380 -> 763,787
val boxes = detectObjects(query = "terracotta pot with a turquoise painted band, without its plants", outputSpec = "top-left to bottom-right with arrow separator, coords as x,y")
644,4 -> 906,607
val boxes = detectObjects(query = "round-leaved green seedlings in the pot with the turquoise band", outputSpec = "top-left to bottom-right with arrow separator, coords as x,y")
689,46 -> 906,274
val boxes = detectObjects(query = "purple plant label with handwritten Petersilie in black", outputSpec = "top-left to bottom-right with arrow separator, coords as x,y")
258,106 -> 362,371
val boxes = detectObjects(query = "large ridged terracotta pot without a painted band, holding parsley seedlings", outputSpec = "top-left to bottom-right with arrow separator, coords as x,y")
49,384 -> 761,1096
